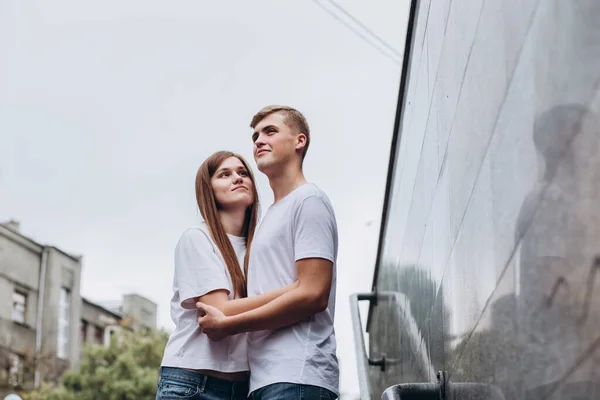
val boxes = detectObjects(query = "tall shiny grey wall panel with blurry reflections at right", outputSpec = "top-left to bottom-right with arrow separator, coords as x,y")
370,0 -> 600,399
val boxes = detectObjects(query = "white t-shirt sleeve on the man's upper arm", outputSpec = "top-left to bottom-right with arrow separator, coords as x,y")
294,196 -> 337,262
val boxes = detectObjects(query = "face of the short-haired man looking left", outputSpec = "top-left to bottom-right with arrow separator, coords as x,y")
252,113 -> 305,175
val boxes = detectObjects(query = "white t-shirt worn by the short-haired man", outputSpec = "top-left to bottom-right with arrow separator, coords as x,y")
248,183 -> 339,395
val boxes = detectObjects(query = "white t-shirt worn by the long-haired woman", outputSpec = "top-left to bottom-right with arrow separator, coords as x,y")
161,223 -> 248,372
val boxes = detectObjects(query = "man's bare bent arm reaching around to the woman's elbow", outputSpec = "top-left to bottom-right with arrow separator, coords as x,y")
198,258 -> 333,340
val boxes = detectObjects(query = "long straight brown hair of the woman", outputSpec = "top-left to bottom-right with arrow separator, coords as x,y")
196,151 -> 259,297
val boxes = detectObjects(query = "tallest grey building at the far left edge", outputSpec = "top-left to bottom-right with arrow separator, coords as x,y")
0,221 -> 81,391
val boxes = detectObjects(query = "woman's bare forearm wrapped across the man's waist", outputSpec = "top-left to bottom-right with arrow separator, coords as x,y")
195,281 -> 298,316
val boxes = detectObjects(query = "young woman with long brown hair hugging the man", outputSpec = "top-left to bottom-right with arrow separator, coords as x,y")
156,151 -> 293,400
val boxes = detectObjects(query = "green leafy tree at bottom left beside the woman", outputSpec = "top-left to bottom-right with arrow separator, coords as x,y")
25,330 -> 168,400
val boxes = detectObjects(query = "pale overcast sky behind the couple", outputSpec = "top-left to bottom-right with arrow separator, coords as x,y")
0,0 -> 408,393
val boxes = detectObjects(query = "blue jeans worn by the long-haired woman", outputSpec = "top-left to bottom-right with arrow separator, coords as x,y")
156,367 -> 248,400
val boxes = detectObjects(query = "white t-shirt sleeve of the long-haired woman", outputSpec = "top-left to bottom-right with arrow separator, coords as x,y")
175,229 -> 229,309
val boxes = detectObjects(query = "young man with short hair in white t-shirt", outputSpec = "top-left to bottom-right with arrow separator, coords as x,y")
198,106 -> 339,400
